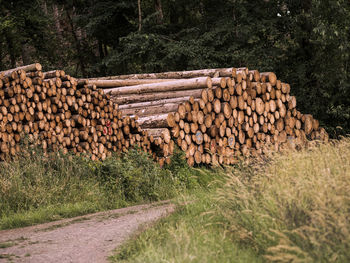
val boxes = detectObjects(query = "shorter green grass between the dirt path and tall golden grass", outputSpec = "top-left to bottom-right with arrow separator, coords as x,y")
110,172 -> 262,263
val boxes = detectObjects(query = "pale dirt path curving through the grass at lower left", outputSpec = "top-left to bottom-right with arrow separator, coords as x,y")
0,202 -> 174,263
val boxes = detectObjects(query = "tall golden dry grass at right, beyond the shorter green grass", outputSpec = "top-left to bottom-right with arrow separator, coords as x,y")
219,138 -> 350,262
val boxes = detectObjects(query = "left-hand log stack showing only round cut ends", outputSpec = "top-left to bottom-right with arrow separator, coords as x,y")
0,63 -> 165,164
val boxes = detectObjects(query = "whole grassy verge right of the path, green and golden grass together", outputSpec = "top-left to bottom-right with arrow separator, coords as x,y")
111,139 -> 350,263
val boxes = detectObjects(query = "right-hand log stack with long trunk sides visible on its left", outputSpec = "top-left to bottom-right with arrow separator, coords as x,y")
85,68 -> 328,166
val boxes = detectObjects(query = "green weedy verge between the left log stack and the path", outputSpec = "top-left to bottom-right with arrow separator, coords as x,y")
0,148 -> 209,229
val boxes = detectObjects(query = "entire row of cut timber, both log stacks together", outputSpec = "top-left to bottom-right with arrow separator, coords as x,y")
0,63 -> 328,166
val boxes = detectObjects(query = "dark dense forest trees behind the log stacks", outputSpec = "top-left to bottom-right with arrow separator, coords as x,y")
0,0 -> 350,136
